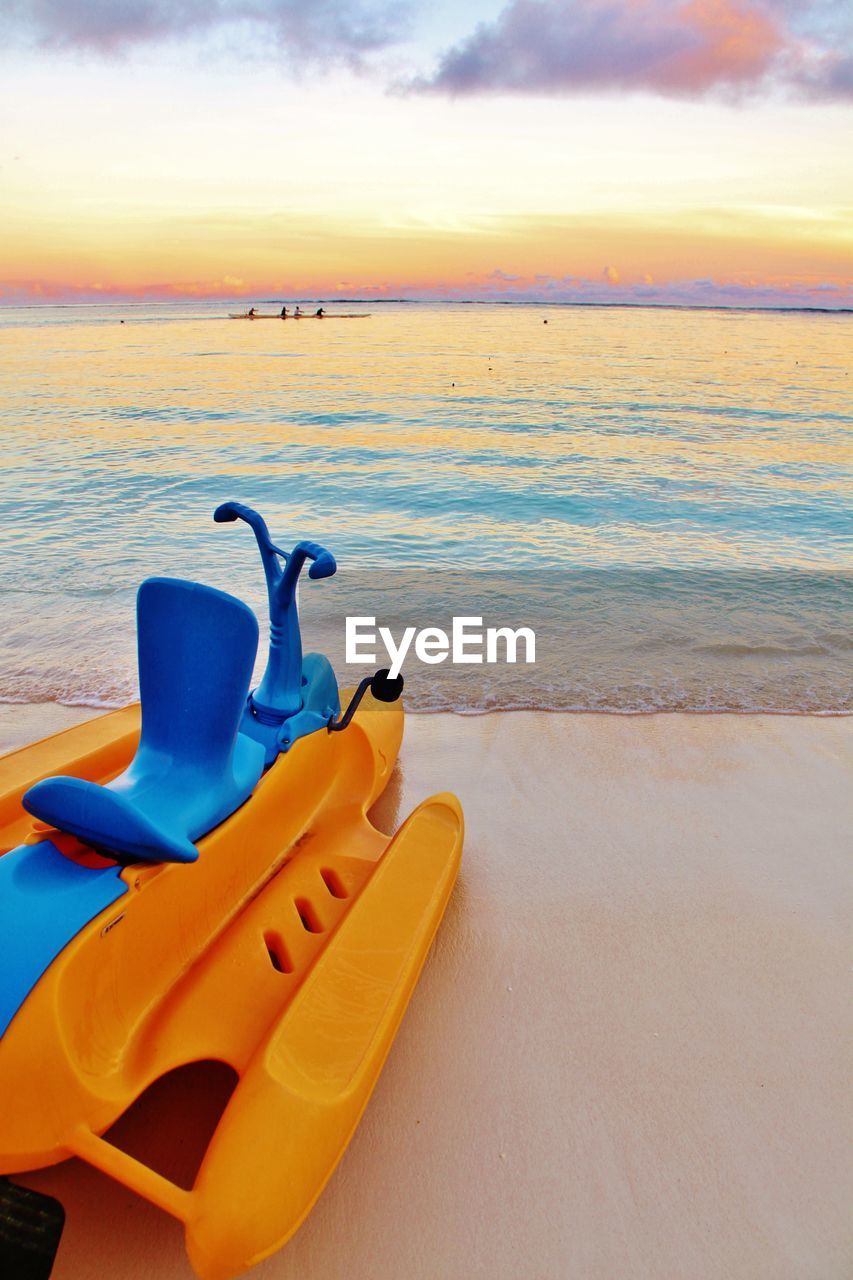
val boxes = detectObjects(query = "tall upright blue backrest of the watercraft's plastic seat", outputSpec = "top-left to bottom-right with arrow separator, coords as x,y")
137,577 -> 257,773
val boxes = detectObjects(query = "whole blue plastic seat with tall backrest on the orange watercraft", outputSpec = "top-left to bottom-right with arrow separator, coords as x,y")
23,577 -> 264,863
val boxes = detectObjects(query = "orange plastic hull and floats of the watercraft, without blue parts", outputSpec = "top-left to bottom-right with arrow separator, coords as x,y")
0,698 -> 462,1280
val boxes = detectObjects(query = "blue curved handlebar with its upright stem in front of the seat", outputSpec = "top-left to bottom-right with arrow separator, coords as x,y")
214,502 -> 338,719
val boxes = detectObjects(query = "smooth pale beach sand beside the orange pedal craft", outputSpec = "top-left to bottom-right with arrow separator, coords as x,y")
0,707 -> 853,1280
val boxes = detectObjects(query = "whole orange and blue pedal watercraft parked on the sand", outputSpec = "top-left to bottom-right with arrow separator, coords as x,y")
0,503 -> 462,1280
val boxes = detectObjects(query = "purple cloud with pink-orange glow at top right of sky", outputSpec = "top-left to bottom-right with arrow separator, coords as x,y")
412,0 -> 853,99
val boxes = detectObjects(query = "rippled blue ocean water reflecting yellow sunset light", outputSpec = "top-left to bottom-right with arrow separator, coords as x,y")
0,303 -> 853,713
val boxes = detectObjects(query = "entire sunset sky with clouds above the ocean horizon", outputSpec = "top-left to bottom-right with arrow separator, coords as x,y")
0,0 -> 853,307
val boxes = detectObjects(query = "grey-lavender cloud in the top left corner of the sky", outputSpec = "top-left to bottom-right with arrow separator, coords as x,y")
0,0 -> 409,63
